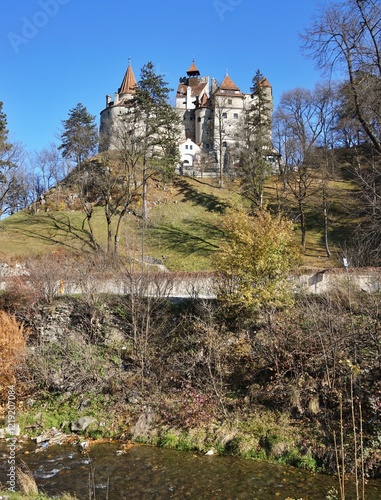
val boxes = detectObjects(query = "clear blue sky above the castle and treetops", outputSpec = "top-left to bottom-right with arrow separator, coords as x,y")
0,0 -> 328,151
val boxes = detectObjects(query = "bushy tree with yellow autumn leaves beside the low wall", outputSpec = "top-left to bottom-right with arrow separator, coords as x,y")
215,208 -> 298,310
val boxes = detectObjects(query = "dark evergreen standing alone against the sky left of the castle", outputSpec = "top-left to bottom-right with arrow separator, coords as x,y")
58,103 -> 98,166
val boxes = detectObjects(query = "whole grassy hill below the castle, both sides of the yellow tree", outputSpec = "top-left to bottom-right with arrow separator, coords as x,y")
0,165 -> 358,271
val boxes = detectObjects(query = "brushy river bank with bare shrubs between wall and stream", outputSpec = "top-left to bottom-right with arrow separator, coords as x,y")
0,292 -> 381,488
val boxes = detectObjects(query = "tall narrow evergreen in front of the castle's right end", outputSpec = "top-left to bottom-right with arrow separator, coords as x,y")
239,70 -> 272,208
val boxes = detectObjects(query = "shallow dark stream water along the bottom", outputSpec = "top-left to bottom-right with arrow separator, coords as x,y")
0,444 -> 381,500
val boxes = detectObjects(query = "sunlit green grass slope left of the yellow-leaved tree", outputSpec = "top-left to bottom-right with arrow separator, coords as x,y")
0,179 -> 239,271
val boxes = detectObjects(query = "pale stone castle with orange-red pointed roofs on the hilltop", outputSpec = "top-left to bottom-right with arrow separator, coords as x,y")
100,61 -> 273,175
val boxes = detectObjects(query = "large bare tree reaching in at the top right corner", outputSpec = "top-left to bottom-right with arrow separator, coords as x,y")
303,0 -> 381,153
